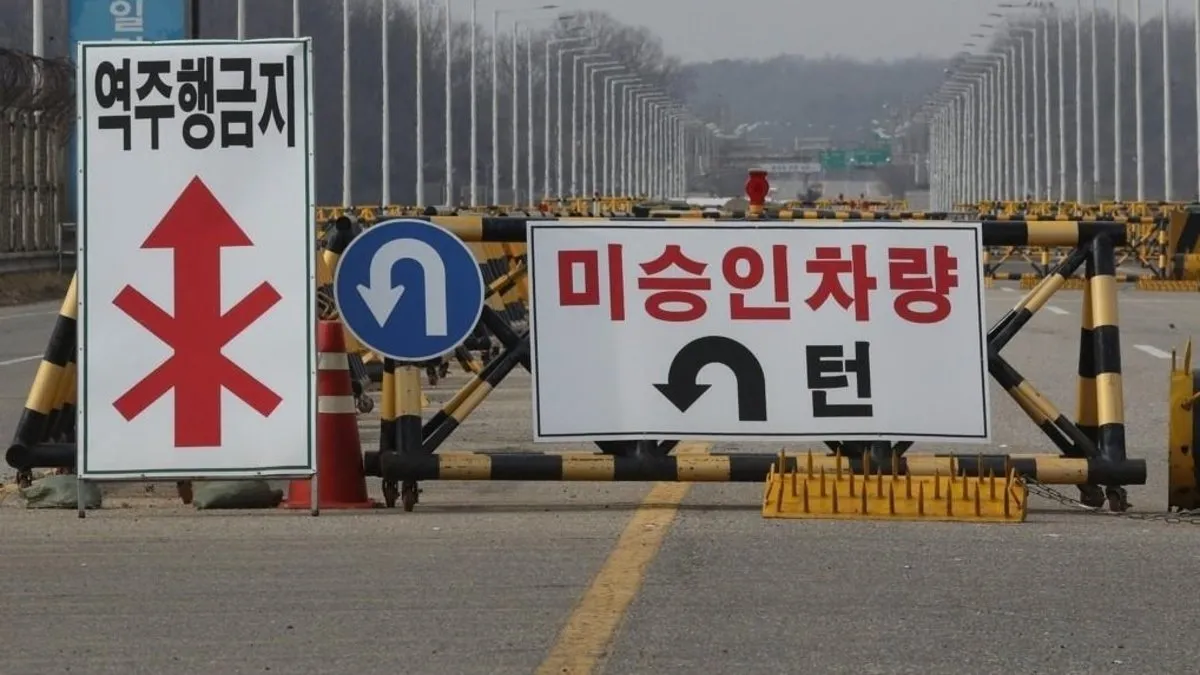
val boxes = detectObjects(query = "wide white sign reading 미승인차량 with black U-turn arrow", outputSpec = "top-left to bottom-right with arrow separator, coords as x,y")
528,221 -> 990,443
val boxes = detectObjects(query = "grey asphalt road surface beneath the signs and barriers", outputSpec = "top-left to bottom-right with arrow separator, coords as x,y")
0,285 -> 1200,675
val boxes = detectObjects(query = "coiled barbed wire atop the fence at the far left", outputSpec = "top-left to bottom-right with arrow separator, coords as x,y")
0,48 -> 76,124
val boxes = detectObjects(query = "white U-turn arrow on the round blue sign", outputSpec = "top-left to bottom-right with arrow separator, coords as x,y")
359,239 -> 449,336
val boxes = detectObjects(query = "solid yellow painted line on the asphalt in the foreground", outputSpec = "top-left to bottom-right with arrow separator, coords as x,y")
536,443 -> 712,675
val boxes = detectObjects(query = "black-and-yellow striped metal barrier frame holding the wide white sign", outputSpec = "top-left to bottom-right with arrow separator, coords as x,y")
300,216 -> 1146,510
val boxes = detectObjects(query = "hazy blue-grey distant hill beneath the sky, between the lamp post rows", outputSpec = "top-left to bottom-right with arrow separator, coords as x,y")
684,55 -> 948,145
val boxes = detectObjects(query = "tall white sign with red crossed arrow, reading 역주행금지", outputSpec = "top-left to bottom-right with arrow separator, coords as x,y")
77,38 -> 317,479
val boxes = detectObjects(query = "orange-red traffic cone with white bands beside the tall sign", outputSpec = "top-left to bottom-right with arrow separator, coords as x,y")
283,321 -> 374,509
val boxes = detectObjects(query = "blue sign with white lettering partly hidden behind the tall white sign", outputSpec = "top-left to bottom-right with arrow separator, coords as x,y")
67,0 -> 188,217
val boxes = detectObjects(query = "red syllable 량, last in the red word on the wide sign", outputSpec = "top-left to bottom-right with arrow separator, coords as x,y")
888,246 -> 959,323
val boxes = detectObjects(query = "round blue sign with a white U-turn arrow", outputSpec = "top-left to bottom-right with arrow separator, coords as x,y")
334,219 -> 484,362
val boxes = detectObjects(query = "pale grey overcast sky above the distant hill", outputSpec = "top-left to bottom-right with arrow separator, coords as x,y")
475,0 -> 1171,61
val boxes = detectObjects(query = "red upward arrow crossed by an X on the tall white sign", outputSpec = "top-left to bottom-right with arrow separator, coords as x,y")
113,177 -> 282,448
